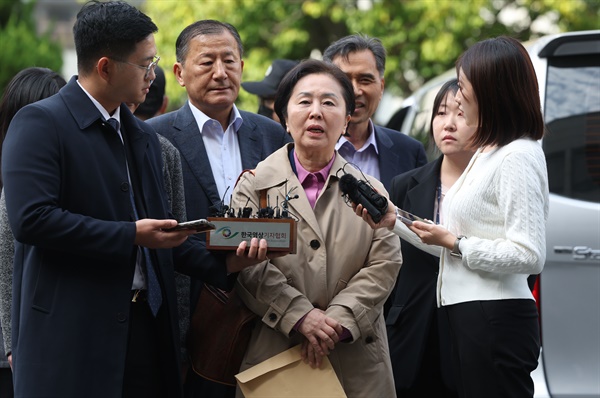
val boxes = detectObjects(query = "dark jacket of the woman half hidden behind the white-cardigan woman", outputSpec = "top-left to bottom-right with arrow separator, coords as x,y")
386,157 -> 450,392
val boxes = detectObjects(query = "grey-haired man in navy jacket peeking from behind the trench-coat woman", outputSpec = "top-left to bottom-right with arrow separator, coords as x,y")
323,34 -> 427,191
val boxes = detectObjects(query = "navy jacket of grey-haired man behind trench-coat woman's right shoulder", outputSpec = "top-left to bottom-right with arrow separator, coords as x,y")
375,125 -> 427,192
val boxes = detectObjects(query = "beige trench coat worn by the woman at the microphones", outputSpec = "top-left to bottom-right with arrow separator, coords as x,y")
232,144 -> 402,398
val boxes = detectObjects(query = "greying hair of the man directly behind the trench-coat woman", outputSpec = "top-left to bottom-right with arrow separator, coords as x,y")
323,33 -> 386,77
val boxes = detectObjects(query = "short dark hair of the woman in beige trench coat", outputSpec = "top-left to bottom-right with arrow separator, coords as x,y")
274,59 -> 355,130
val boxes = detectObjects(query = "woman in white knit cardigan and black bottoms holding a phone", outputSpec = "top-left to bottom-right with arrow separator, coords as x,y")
356,37 -> 548,398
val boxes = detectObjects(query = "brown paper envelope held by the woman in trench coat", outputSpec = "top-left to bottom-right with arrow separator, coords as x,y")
235,345 -> 346,398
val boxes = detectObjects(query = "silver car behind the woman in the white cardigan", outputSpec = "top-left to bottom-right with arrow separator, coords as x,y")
392,30 -> 600,398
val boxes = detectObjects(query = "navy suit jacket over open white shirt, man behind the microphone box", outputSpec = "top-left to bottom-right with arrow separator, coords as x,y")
148,103 -> 292,225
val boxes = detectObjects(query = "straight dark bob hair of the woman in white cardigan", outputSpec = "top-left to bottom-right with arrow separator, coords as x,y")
456,36 -> 544,147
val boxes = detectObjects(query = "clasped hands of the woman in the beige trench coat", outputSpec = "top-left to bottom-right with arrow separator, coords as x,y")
298,308 -> 343,368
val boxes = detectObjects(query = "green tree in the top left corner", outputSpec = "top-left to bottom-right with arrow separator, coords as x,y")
0,0 -> 62,93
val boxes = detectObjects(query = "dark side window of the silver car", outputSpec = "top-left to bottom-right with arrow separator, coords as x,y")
543,55 -> 600,202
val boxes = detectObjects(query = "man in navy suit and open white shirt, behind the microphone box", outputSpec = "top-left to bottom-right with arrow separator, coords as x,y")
148,20 -> 291,397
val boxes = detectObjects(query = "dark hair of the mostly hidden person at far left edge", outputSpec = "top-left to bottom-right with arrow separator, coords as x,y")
0,67 -> 67,185
